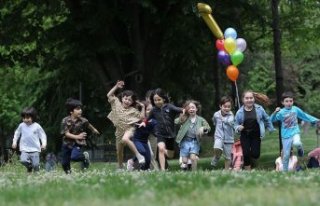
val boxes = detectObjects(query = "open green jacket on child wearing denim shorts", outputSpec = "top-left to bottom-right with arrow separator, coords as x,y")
174,115 -> 211,144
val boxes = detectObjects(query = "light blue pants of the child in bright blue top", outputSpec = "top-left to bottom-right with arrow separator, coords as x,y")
281,134 -> 302,172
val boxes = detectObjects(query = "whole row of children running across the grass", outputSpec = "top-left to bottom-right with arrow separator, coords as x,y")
12,81 -> 319,174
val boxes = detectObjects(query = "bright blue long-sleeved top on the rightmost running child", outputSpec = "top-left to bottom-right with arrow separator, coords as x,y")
271,106 -> 319,139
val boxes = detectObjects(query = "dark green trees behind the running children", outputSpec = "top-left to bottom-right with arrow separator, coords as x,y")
0,0 -> 320,154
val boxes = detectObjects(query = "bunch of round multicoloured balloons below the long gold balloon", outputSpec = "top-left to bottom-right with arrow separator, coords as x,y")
216,28 -> 247,82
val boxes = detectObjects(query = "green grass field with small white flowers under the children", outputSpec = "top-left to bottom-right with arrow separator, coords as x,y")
0,129 -> 320,206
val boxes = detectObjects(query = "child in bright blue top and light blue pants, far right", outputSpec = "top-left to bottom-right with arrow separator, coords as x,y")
271,92 -> 319,172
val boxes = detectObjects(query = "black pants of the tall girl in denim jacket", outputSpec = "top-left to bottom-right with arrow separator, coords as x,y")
240,131 -> 261,166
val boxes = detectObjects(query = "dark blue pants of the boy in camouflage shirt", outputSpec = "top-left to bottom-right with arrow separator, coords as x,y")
61,144 -> 85,174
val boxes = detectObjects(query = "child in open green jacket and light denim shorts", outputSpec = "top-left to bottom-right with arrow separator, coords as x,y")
175,100 -> 210,171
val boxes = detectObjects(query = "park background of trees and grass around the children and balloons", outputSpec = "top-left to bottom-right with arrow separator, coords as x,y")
0,0 -> 320,206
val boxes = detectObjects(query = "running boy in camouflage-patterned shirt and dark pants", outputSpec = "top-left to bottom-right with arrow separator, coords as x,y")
61,98 -> 99,174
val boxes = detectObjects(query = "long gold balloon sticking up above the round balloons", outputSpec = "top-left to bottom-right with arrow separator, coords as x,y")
197,3 -> 223,39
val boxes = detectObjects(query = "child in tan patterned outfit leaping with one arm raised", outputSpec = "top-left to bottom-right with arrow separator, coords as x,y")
107,81 -> 145,170
